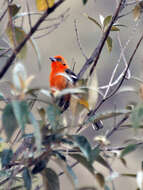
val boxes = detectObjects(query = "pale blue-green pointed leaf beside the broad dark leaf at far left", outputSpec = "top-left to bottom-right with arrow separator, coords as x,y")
12,101 -> 29,133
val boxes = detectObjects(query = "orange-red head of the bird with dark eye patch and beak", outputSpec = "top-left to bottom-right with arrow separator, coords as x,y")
49,55 -> 68,72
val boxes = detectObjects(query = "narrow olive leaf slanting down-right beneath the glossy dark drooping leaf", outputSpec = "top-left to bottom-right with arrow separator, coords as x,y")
69,154 -> 95,175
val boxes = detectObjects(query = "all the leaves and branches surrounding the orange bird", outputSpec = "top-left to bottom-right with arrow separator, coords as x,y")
0,0 -> 143,190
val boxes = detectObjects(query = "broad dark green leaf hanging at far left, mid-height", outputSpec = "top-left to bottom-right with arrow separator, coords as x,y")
2,104 -> 18,141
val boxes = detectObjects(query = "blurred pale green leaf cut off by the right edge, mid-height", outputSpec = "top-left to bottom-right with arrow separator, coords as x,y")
131,104 -> 143,128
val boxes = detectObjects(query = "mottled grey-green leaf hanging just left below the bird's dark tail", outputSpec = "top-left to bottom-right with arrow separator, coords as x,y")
46,104 -> 61,130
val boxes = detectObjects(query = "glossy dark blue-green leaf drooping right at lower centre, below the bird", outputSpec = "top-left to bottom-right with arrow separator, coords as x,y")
72,135 -> 92,161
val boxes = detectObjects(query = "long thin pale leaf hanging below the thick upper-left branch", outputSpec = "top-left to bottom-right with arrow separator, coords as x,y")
29,37 -> 41,69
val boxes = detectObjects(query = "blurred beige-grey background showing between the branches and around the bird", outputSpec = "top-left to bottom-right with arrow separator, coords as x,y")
0,0 -> 143,190
